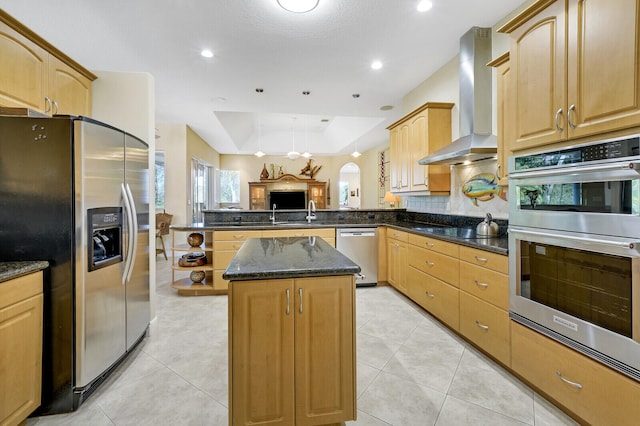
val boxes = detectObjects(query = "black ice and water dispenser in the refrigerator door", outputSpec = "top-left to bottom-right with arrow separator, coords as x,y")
87,207 -> 122,271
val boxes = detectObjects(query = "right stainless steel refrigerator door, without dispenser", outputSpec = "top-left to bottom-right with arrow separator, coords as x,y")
125,134 -> 150,350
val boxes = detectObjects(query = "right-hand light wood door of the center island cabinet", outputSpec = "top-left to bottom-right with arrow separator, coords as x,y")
295,276 -> 356,426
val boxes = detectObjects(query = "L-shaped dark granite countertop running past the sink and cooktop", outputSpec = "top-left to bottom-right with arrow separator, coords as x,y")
171,220 -> 509,256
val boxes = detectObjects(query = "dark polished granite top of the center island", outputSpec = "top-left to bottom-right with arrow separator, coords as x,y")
222,237 -> 360,281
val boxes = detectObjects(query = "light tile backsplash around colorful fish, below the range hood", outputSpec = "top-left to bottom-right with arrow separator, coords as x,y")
401,160 -> 509,219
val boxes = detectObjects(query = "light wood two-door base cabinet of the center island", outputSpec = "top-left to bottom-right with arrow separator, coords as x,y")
229,275 -> 356,426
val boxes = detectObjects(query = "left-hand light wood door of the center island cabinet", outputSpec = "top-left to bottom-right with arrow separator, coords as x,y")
229,279 -> 295,426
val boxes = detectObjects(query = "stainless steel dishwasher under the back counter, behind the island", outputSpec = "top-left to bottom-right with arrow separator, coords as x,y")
336,228 -> 378,287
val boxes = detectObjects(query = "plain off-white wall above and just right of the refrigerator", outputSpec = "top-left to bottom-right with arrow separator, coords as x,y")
91,70 -> 156,320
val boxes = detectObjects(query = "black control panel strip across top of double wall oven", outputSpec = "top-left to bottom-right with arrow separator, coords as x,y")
513,136 -> 640,172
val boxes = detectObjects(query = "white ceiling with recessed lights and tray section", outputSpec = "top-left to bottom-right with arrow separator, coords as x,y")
0,0 -> 523,155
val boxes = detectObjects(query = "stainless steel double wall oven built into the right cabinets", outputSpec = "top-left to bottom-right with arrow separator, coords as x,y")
509,135 -> 640,380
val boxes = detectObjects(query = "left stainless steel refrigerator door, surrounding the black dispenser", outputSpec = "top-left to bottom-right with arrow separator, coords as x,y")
74,120 -> 127,388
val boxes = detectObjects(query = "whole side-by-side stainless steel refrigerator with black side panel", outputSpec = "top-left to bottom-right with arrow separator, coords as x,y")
0,116 -> 149,414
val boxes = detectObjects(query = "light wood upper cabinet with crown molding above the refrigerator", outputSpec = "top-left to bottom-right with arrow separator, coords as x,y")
0,10 -> 96,116
